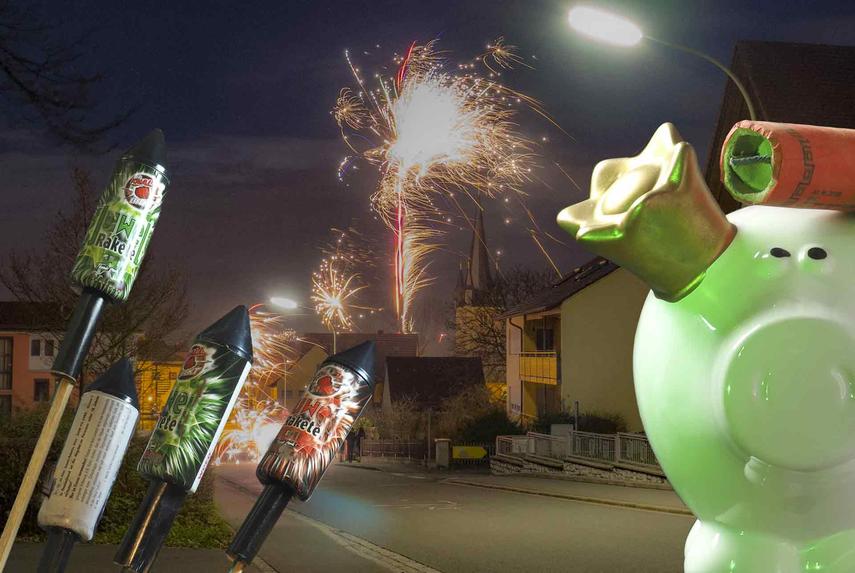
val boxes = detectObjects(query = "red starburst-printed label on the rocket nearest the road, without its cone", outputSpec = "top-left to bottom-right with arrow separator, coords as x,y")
258,364 -> 372,500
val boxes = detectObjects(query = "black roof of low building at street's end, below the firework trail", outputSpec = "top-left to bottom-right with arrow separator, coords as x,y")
383,356 -> 484,408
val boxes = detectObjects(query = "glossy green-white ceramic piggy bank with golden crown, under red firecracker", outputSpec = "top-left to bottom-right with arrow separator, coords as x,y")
558,124 -> 855,573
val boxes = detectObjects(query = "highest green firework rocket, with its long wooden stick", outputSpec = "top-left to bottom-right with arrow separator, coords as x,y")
0,129 -> 169,571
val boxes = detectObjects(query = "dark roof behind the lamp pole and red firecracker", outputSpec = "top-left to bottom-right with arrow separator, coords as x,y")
706,42 -> 855,212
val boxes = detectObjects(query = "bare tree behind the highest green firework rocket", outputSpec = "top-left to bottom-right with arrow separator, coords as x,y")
0,169 -> 187,384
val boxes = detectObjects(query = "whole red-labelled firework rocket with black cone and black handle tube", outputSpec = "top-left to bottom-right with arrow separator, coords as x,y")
227,341 -> 374,571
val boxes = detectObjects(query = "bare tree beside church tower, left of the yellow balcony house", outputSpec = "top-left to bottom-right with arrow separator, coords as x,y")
449,267 -> 555,380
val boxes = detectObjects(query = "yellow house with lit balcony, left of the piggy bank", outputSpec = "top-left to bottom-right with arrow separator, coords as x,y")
502,258 -> 649,431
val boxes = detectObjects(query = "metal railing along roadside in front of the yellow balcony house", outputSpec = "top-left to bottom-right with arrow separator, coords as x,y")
495,431 -> 659,468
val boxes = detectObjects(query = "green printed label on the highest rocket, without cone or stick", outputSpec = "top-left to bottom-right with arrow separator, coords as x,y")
71,161 -> 166,301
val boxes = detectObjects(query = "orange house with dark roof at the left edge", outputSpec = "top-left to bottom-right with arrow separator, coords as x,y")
0,301 -> 65,417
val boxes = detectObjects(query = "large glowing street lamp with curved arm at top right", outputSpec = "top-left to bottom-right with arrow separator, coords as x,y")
568,6 -> 757,120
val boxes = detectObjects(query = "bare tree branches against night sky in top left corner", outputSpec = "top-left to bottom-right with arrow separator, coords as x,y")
0,0 -> 133,149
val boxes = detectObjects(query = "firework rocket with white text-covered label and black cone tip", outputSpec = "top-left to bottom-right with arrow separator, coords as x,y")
38,358 -> 139,573
